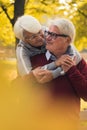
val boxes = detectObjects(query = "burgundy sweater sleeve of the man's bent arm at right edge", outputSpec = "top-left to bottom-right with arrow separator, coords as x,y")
66,59 -> 87,101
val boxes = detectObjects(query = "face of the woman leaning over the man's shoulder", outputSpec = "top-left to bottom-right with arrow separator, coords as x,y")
23,30 -> 44,47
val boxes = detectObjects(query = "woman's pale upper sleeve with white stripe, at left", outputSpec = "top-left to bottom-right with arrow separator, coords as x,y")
16,45 -> 32,76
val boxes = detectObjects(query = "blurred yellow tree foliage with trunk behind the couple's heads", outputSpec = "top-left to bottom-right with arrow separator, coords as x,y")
0,0 -> 87,51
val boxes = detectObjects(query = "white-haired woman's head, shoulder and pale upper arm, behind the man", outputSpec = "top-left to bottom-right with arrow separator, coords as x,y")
14,15 -> 46,76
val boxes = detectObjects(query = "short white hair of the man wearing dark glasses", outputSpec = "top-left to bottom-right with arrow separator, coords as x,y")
49,18 -> 76,42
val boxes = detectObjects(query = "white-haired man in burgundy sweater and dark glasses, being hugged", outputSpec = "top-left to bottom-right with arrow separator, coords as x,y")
27,18 -> 87,130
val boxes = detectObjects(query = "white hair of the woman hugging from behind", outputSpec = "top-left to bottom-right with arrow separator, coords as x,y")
14,15 -> 41,40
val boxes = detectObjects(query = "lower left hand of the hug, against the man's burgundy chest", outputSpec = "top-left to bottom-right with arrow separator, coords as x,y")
33,67 -> 53,83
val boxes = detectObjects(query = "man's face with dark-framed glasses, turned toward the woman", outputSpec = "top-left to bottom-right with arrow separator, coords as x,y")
46,25 -> 69,57
